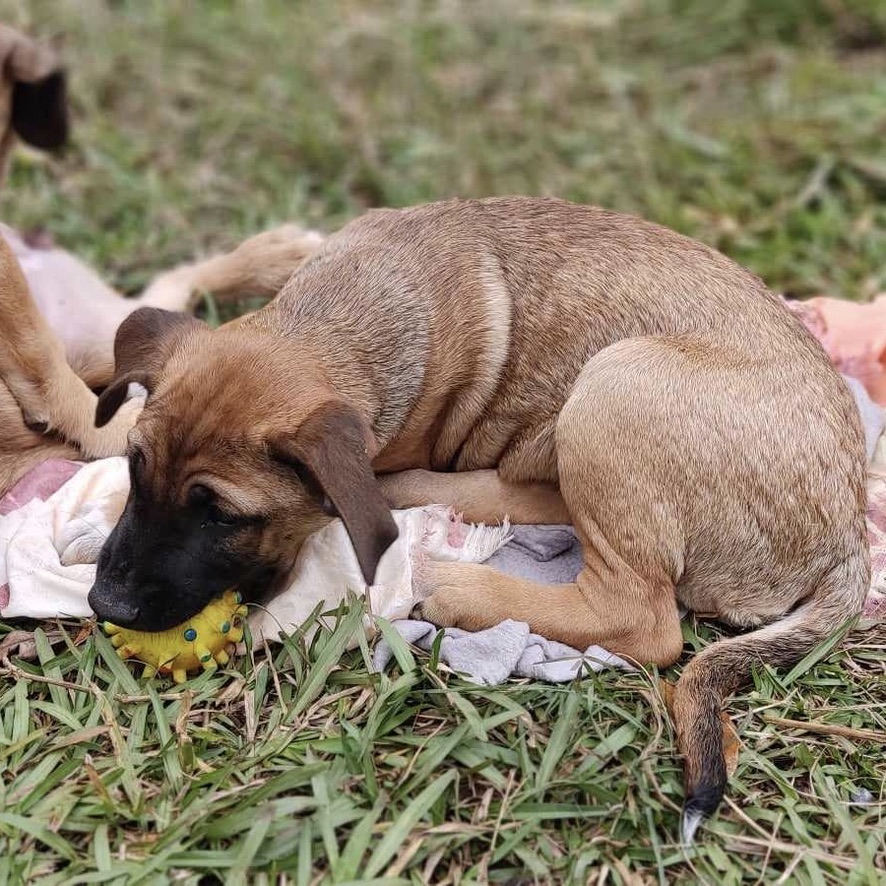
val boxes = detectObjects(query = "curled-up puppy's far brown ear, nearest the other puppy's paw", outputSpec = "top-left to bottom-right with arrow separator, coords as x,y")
95,308 -> 209,428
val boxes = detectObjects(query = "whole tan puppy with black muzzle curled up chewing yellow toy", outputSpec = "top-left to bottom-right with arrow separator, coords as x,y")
90,198 -> 869,838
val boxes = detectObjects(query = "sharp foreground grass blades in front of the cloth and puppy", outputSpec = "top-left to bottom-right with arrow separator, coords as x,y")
0,609 -> 886,884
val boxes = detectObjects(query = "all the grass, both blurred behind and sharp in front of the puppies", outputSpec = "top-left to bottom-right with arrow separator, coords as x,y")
0,0 -> 886,886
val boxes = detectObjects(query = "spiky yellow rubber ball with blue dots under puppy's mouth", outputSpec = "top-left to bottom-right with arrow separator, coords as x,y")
102,591 -> 246,683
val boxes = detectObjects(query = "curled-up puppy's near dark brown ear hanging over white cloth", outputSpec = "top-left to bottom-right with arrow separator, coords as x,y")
268,401 -> 399,585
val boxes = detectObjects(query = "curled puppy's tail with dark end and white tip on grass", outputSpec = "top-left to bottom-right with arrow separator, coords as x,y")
674,550 -> 870,845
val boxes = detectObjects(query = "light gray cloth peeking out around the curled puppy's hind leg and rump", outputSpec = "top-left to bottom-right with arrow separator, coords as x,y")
373,376 -> 886,685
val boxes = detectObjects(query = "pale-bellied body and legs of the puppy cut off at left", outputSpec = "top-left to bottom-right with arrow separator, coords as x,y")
0,225 -> 322,495
